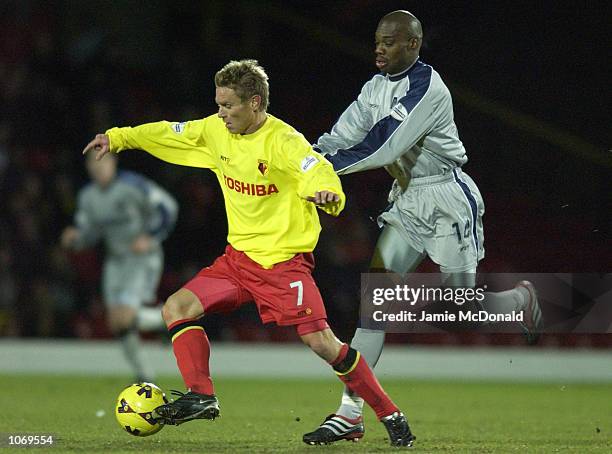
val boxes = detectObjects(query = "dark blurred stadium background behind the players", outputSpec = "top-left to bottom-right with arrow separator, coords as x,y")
0,0 -> 612,346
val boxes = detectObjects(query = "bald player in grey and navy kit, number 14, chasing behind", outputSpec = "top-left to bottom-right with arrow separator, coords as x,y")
304,11 -> 541,444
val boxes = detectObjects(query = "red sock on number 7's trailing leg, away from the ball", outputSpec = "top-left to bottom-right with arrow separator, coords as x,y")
330,344 -> 399,419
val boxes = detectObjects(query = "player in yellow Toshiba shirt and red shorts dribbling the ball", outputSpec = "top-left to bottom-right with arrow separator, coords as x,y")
83,60 -> 414,446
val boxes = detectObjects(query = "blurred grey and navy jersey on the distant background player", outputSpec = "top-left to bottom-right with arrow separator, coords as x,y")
75,171 -> 178,256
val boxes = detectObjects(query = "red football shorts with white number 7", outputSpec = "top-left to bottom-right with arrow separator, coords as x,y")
184,245 -> 328,335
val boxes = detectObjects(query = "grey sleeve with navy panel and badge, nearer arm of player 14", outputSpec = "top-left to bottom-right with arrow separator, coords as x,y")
327,66 -> 439,175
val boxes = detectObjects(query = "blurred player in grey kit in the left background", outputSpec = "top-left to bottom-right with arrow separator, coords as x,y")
61,154 -> 178,381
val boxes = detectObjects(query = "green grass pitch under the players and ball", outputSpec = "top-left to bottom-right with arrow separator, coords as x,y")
0,376 -> 612,454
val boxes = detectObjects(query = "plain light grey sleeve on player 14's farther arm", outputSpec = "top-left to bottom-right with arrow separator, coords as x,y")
314,83 -> 373,155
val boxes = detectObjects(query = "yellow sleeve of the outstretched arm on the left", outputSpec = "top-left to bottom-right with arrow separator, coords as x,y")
106,119 -> 215,169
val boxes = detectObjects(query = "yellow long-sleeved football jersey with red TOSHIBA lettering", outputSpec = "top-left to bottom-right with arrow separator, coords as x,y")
106,114 -> 346,268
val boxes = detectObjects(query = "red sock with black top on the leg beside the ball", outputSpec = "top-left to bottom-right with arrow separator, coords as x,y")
168,319 -> 215,395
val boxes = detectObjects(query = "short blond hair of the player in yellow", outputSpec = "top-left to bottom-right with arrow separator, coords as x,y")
215,60 -> 270,112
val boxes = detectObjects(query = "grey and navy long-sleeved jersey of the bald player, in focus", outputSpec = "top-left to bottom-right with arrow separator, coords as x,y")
314,60 -> 467,195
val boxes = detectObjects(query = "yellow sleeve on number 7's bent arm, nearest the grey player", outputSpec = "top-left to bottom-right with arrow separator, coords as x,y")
281,132 -> 346,216
